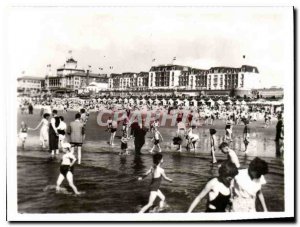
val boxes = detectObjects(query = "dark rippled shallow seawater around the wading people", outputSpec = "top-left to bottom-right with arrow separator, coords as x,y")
18,110 -> 284,213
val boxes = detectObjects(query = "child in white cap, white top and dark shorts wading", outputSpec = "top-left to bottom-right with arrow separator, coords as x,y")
56,143 -> 80,195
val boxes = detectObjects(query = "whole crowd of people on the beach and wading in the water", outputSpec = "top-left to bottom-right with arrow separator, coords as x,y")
20,95 -> 284,213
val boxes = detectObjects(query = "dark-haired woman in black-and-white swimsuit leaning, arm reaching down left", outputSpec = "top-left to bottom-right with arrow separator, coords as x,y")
188,161 -> 238,213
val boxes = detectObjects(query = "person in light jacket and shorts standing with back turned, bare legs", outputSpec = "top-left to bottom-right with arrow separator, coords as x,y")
68,113 -> 84,164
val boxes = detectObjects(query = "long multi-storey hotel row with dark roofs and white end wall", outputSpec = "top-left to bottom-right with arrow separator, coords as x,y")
108,65 -> 260,94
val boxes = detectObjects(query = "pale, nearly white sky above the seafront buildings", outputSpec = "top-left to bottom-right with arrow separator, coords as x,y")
5,7 -> 293,87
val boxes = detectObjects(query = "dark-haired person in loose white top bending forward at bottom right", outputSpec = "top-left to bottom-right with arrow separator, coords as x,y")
232,157 -> 269,212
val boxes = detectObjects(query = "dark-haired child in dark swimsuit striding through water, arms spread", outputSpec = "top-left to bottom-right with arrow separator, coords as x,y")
138,153 -> 172,213
